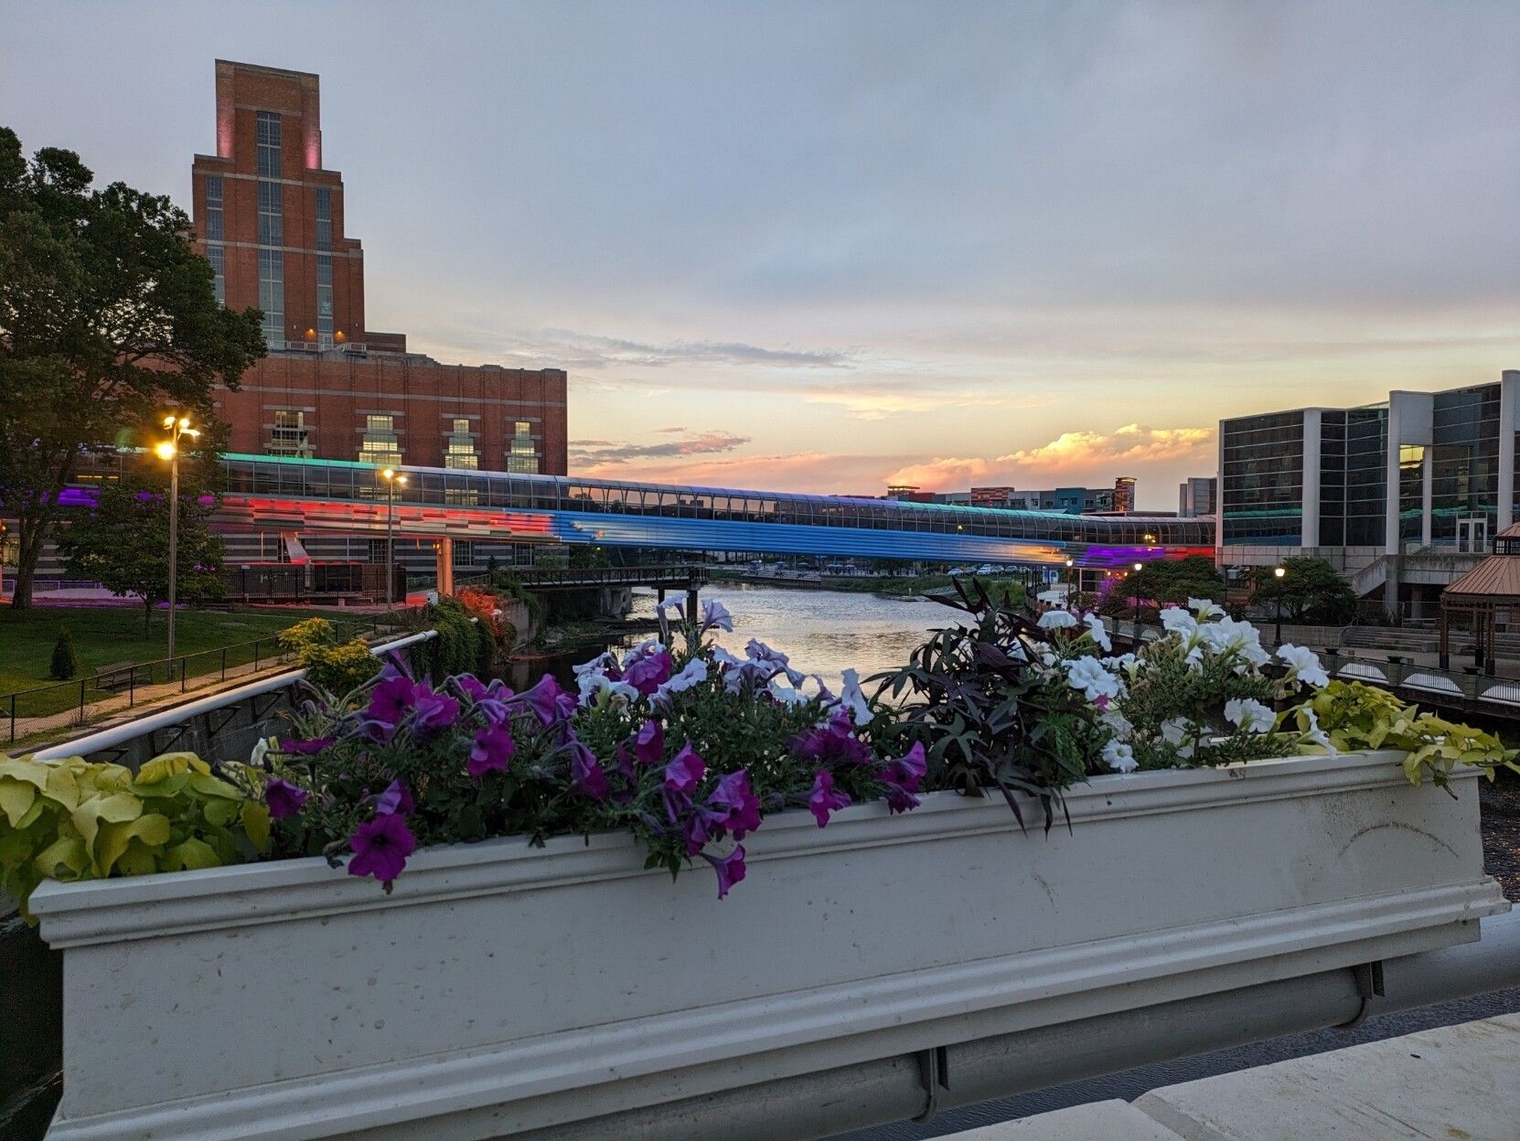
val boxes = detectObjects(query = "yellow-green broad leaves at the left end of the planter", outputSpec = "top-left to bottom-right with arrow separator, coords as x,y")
0,752 -> 269,922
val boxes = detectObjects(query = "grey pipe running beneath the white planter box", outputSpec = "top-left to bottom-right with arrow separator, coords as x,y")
522,912 -> 1520,1141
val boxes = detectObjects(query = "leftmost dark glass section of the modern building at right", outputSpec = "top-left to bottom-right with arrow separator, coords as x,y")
1219,412 -> 1304,547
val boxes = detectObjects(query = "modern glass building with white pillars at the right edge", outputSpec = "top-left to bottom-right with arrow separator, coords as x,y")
1216,371 -> 1520,617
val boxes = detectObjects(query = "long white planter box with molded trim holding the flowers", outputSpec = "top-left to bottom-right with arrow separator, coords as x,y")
32,754 -> 1508,1141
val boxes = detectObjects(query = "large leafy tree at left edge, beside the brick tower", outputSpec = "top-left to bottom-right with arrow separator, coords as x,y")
0,128 -> 264,609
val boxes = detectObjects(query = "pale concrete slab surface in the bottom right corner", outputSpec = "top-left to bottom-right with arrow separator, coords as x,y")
941,1015 -> 1520,1141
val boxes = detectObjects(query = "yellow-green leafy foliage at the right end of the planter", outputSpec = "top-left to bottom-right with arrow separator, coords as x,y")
1283,681 -> 1520,787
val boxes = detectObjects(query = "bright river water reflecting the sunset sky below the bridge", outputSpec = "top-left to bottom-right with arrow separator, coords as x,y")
631,583 -> 961,693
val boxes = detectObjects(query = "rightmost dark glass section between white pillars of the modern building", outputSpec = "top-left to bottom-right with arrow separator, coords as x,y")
1428,384 -> 1499,542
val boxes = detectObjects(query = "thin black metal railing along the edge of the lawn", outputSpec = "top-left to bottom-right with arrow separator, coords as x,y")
0,620 -> 395,743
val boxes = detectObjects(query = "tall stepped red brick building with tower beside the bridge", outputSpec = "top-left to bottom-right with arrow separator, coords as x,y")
192,59 -> 567,474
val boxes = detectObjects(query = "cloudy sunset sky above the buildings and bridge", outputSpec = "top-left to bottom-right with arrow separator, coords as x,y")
0,0 -> 1520,510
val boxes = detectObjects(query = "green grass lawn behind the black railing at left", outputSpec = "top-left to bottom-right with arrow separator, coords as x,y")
0,606 -> 366,693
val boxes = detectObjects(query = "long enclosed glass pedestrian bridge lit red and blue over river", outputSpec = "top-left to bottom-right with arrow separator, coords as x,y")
219,454 -> 1214,567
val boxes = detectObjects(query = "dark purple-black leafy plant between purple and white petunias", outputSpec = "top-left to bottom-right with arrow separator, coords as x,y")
871,582 -> 1107,830
